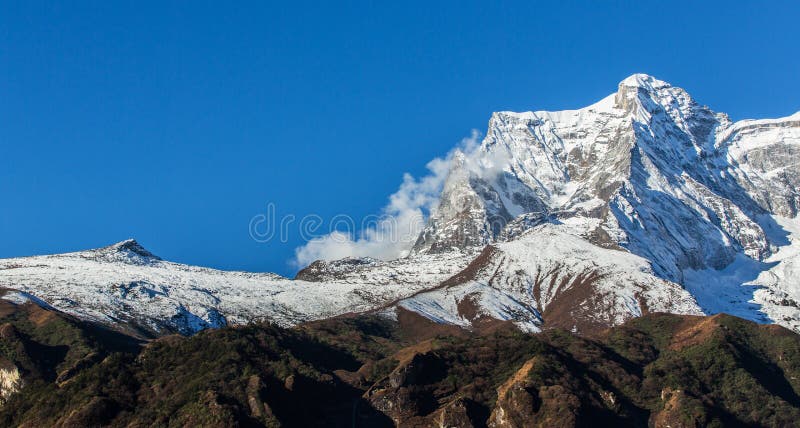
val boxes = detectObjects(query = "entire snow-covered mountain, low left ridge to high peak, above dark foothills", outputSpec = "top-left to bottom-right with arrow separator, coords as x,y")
0,74 -> 800,334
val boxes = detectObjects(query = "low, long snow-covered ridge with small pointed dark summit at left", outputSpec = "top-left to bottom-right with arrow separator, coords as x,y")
0,240 -> 468,335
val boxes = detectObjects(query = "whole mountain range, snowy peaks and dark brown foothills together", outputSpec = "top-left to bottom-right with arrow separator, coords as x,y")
0,74 -> 800,428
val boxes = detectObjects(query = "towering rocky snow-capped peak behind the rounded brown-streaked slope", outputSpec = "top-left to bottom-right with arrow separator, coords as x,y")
406,74 -> 800,329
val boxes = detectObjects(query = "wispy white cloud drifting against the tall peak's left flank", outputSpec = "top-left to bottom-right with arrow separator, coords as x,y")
293,129 -> 494,267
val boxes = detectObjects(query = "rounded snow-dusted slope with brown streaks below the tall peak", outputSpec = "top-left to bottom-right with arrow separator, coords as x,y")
399,223 -> 702,332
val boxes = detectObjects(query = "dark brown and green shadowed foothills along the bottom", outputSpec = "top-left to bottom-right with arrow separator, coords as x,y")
0,301 -> 800,427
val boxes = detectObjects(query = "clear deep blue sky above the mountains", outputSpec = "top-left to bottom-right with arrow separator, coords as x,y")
0,1 -> 800,274
